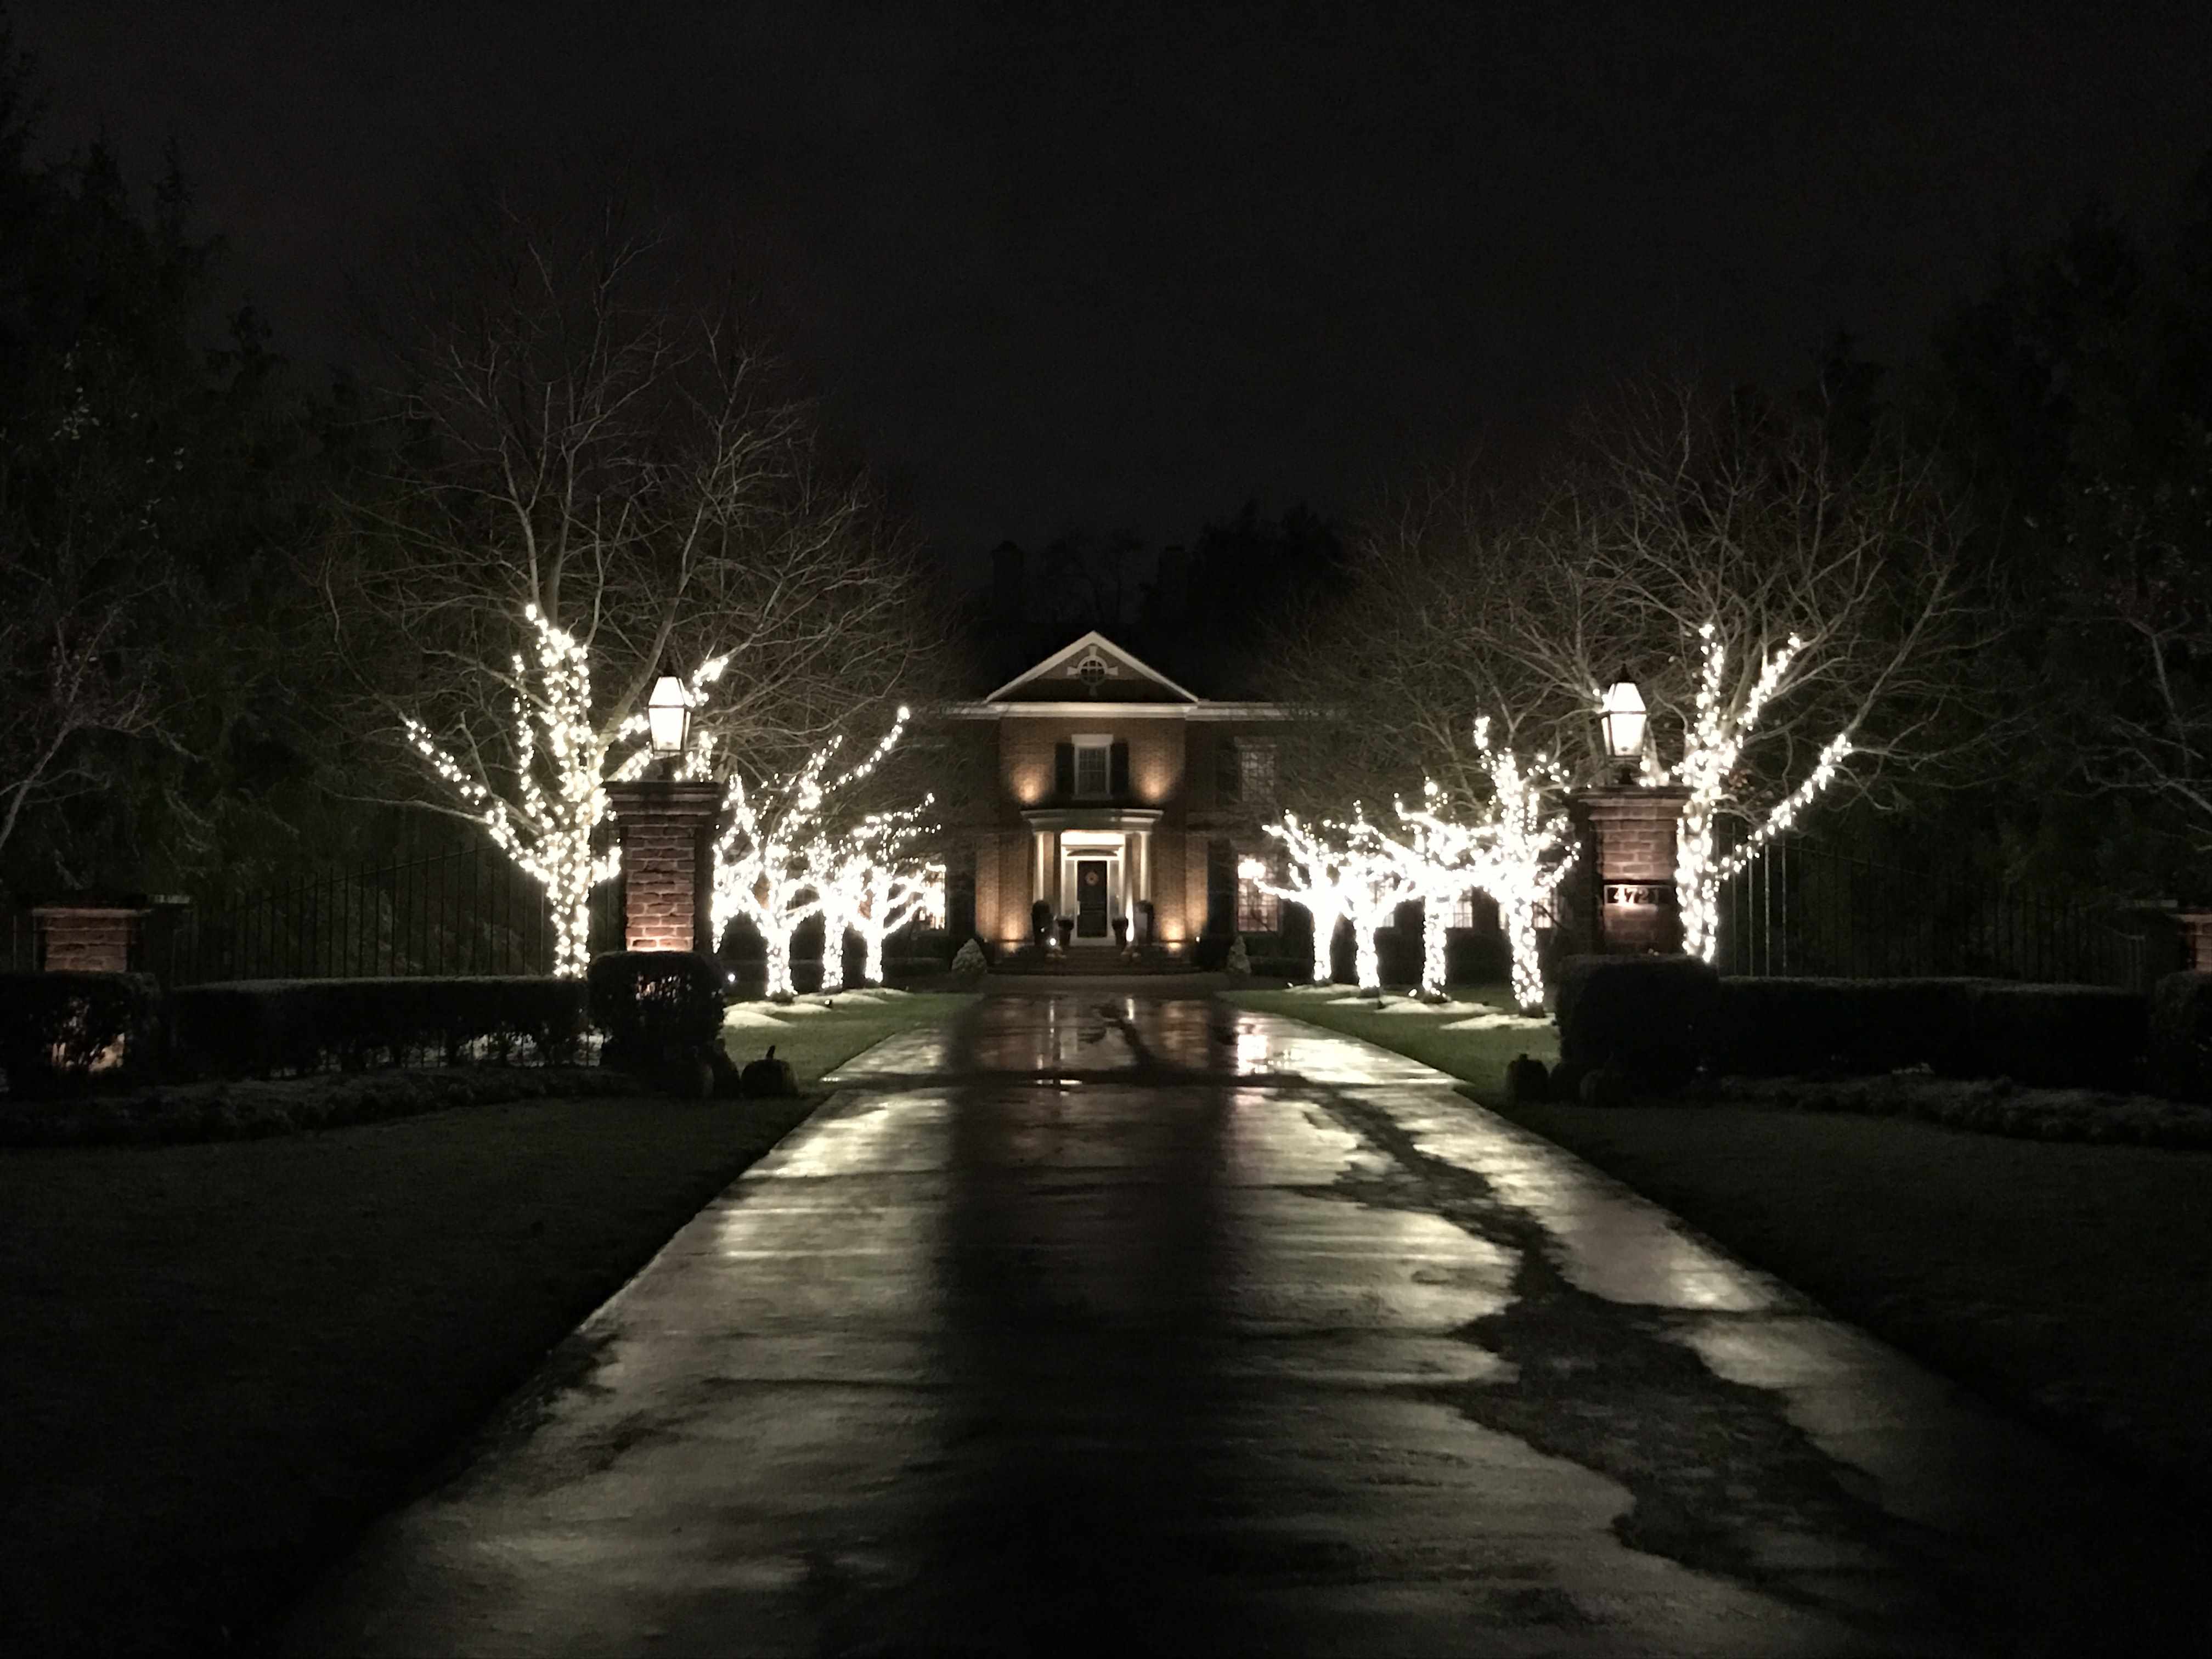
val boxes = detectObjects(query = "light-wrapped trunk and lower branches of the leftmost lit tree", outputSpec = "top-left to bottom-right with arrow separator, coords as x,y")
405,604 -> 730,978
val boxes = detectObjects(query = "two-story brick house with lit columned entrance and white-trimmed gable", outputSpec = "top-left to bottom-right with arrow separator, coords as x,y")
947,633 -> 1288,953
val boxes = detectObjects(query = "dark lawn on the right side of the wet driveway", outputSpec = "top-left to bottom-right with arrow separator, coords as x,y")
1230,991 -> 2212,1500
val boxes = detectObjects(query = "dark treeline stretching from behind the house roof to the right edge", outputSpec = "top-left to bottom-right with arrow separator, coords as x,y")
973,149 -> 2212,900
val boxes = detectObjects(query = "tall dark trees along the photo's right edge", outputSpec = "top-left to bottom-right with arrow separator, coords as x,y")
1812,159 -> 2212,900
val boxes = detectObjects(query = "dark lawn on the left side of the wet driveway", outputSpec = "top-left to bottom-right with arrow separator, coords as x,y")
0,997 -> 964,1652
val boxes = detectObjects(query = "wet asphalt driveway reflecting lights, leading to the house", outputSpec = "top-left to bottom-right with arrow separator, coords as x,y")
287,989 -> 2203,1655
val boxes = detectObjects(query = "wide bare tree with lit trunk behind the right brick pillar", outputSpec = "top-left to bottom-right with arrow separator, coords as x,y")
1292,390 -> 1987,947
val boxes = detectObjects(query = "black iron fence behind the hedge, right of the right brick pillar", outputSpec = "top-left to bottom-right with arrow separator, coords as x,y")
1719,840 -> 2159,989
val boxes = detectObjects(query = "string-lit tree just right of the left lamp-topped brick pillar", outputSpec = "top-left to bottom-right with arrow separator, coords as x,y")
712,708 -> 907,997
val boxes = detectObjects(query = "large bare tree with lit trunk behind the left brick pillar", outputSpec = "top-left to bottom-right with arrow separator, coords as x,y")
323,217 -> 945,956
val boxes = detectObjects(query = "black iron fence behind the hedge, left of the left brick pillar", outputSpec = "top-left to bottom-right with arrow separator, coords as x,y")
4,845 -> 622,984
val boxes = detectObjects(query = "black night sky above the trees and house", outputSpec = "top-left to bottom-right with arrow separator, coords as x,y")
11,0 -> 2212,553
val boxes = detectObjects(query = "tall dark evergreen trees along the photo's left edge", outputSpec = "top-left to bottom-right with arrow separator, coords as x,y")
0,20 -> 371,891
